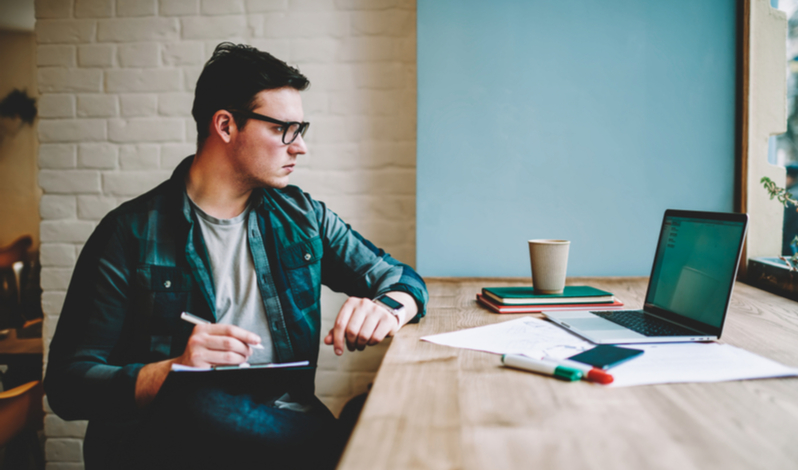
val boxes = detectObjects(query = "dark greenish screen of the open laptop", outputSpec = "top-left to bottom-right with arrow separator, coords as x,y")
645,214 -> 746,328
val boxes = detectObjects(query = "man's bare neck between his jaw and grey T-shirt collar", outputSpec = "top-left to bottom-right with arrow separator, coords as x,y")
186,150 -> 253,219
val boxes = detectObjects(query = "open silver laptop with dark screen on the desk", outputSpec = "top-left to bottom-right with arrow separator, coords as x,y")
544,209 -> 748,344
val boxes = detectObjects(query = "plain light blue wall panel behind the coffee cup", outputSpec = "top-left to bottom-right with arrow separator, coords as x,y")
417,0 -> 736,276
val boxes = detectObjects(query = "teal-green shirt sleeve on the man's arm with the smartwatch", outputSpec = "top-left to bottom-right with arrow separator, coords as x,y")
312,196 -> 428,323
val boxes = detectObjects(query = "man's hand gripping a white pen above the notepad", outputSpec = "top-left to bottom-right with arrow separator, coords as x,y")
174,323 -> 261,367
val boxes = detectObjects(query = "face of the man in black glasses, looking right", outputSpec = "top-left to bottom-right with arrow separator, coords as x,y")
232,87 -> 307,189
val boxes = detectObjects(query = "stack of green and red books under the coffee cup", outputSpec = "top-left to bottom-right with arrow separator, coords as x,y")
477,286 -> 623,313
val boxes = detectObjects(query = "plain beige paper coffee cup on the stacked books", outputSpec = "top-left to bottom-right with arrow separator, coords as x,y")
528,240 -> 569,294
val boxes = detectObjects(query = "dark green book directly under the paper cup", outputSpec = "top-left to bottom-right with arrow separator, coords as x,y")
483,286 -> 614,305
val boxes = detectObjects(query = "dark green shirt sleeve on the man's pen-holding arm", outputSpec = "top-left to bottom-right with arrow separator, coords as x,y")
44,213 -> 144,420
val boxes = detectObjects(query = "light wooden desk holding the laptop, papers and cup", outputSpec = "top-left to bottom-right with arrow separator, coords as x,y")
339,278 -> 798,470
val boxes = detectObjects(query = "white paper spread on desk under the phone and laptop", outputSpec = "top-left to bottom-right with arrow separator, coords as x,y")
421,317 -> 797,387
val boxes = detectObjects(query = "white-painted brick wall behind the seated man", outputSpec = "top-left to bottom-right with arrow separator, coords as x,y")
36,0 -> 416,470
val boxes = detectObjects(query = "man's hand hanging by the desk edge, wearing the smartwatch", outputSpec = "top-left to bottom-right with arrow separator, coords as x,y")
325,292 -> 417,356
